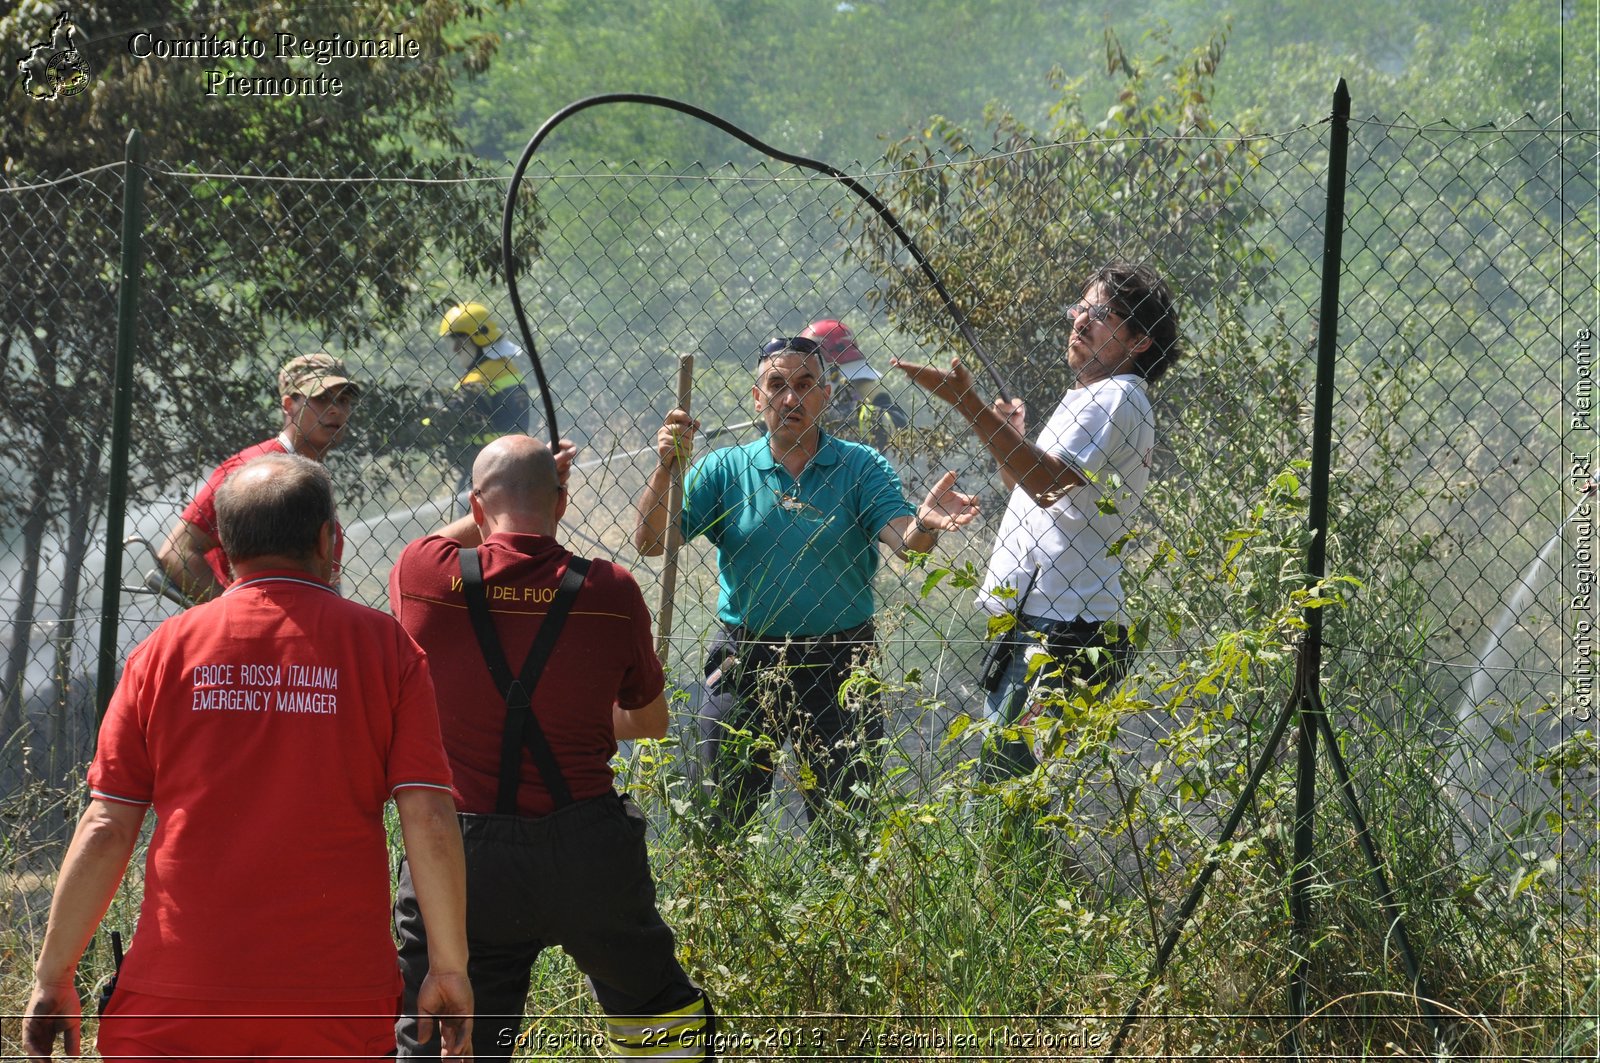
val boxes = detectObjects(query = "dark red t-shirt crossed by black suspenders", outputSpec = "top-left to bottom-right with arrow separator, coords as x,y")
389,533 -> 664,816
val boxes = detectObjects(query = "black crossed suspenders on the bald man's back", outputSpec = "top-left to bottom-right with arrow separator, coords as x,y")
459,546 -> 589,816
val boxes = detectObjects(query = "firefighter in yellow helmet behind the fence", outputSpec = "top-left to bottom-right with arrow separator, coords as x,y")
438,303 -> 533,506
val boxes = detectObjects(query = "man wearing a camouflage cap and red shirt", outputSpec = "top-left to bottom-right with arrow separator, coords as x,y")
157,352 -> 360,602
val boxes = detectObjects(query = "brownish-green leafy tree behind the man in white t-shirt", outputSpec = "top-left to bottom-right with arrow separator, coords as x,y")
856,27 -> 1267,408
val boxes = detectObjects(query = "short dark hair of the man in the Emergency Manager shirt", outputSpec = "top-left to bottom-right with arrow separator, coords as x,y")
216,455 -> 333,564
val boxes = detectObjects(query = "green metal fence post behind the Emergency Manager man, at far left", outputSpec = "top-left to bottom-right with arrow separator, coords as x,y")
94,130 -> 144,732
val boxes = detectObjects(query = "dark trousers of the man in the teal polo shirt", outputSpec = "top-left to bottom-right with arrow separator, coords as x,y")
699,624 -> 883,832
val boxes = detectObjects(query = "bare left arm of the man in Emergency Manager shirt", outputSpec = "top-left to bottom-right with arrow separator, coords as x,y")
22,799 -> 144,1060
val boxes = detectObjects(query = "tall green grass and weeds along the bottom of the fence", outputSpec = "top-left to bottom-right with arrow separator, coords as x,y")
0,592 -> 1595,1058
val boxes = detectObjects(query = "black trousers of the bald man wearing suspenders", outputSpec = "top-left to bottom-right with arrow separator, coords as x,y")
395,794 -> 701,1060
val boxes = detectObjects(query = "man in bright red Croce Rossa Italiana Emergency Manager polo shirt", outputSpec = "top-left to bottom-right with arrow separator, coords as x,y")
22,455 -> 472,1060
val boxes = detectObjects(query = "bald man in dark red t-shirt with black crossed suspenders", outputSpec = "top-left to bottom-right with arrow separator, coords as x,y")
389,435 -> 712,1060
